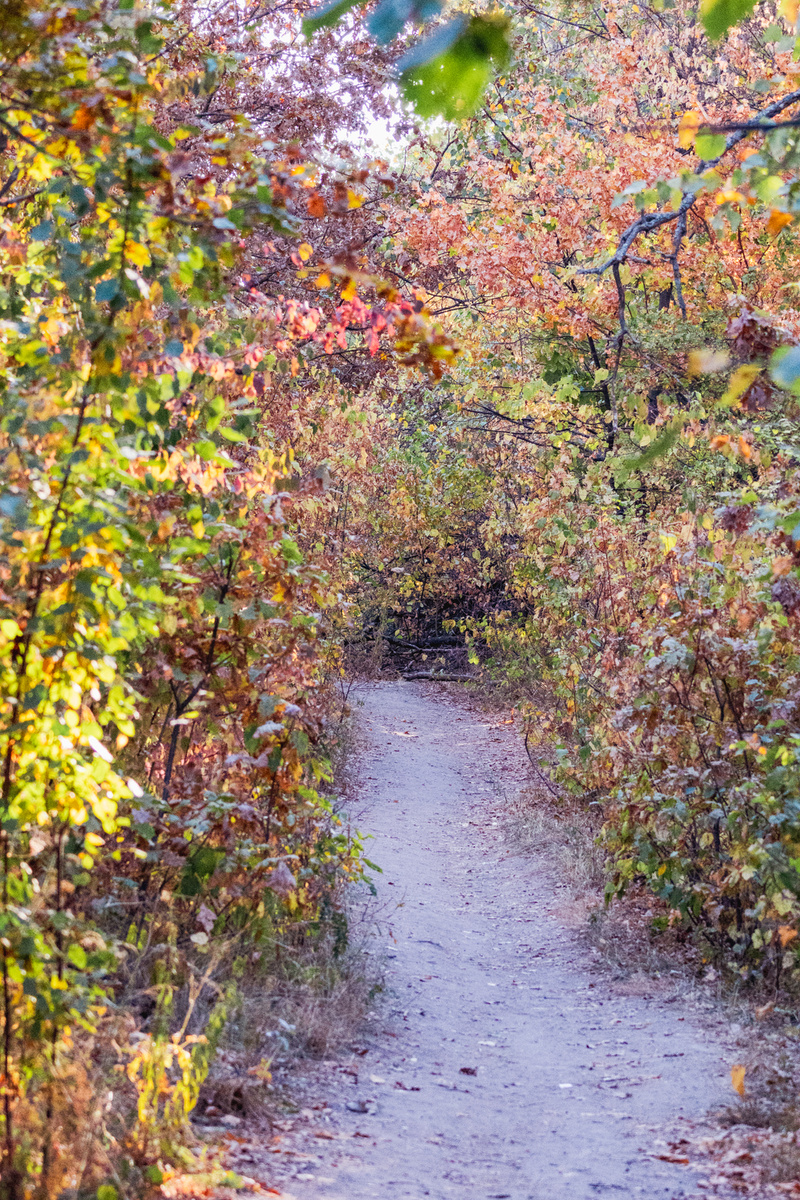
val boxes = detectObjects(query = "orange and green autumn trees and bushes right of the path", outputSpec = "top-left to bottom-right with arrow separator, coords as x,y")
338,5 -> 800,985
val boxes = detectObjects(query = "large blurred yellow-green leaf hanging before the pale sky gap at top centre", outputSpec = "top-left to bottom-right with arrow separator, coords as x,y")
397,13 -> 511,121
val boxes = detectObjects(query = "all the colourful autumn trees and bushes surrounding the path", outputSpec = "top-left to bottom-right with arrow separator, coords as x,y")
0,0 -> 800,1200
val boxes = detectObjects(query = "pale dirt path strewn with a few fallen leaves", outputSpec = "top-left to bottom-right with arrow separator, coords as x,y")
255,683 -> 729,1200
